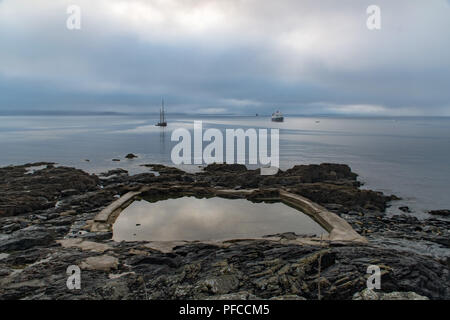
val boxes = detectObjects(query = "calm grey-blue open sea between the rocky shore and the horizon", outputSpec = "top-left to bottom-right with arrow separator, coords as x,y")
0,115 -> 450,217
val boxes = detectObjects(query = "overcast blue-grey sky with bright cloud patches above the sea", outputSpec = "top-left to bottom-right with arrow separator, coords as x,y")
0,0 -> 450,116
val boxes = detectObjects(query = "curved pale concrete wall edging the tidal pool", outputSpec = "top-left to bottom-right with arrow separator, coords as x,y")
91,186 -> 367,244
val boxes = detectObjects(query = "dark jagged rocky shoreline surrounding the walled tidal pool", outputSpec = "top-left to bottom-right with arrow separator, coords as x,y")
0,163 -> 450,299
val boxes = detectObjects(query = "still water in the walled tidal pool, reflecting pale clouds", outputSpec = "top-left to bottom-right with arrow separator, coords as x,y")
113,197 -> 328,241
